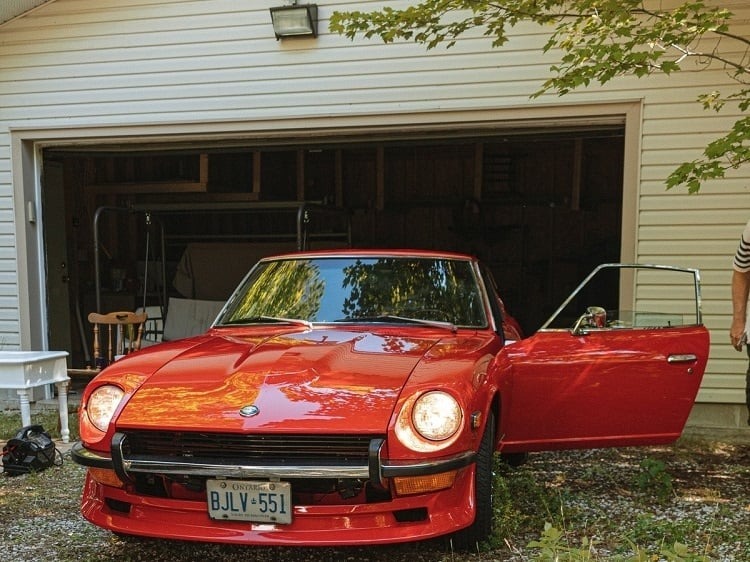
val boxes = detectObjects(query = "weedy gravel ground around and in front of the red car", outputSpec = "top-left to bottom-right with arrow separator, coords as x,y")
0,440 -> 750,562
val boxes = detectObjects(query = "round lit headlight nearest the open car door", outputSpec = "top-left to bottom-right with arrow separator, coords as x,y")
394,390 -> 464,453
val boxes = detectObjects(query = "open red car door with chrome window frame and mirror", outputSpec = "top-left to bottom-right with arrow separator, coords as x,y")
498,264 -> 709,452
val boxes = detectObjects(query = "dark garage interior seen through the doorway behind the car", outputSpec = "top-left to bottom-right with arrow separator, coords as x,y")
42,125 -> 624,367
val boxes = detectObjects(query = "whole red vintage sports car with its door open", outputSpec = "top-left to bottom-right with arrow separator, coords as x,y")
73,250 -> 709,547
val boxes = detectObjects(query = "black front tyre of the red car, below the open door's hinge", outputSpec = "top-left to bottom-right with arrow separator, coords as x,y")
451,406 -> 495,550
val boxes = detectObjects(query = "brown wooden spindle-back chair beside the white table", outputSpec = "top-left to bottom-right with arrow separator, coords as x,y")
68,311 -> 148,377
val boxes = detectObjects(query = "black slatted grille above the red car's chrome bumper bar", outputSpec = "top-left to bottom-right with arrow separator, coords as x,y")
125,431 -> 377,463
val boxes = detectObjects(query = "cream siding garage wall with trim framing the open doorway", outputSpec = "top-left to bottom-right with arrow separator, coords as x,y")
0,0 -> 750,428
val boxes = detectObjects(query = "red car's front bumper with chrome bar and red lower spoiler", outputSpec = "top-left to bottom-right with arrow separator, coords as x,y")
72,434 -> 482,546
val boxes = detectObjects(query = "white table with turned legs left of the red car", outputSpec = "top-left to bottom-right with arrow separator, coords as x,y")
0,351 -> 70,443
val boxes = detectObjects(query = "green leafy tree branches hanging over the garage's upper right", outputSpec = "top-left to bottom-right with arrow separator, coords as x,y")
330,0 -> 750,193
